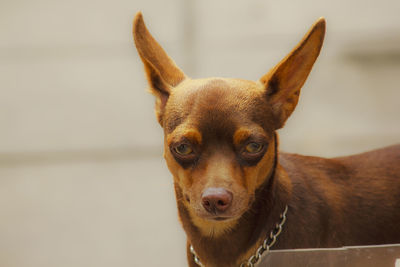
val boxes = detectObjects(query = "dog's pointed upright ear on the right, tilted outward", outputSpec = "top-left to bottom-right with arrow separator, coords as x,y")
260,18 -> 325,129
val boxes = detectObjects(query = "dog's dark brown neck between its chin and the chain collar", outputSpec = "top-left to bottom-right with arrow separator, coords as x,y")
175,135 -> 291,266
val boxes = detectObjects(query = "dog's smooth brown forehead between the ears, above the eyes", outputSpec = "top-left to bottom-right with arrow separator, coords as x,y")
165,78 -> 274,135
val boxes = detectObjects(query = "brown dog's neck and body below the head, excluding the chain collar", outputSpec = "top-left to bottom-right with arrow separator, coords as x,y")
177,145 -> 400,266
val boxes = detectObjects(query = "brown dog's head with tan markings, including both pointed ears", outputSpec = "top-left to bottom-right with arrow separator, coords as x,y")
133,13 -> 325,237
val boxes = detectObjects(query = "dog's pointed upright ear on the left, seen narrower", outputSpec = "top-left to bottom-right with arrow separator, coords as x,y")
133,12 -> 186,125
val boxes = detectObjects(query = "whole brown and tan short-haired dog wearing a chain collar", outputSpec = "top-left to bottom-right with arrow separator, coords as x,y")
133,13 -> 400,266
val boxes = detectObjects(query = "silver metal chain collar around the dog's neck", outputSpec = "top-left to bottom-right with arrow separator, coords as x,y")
190,205 -> 288,267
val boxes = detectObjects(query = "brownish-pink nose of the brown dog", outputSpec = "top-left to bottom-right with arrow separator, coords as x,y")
201,187 -> 232,213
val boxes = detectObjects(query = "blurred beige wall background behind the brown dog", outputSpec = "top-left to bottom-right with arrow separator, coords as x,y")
0,0 -> 400,267
